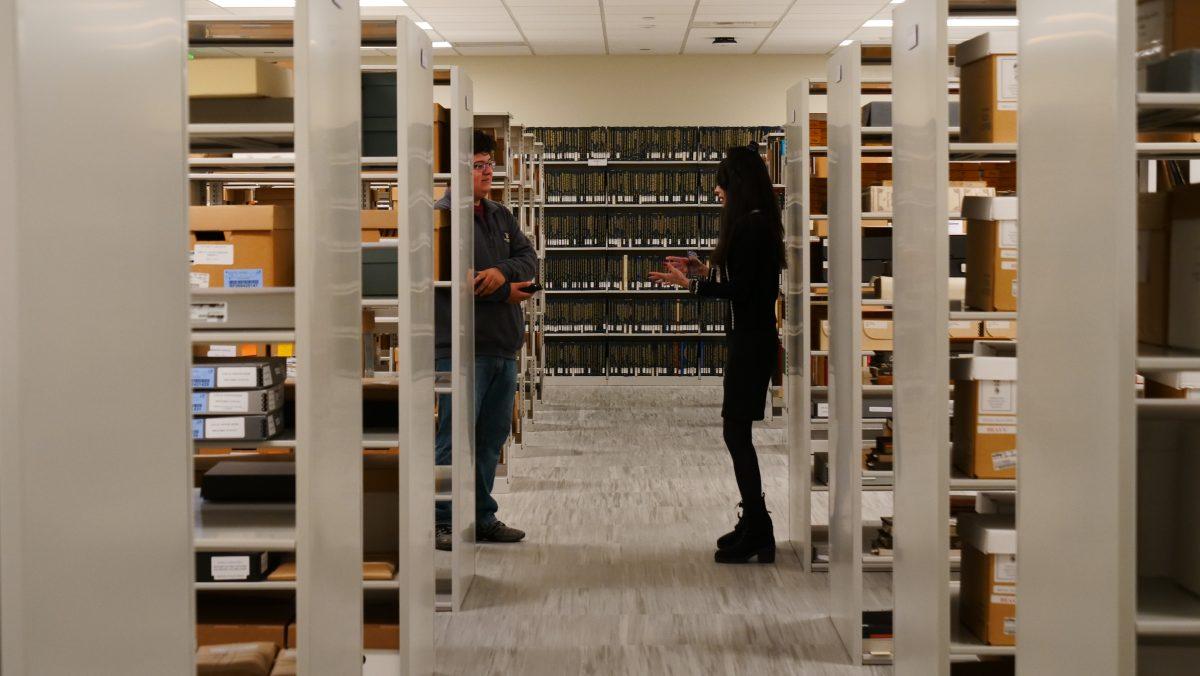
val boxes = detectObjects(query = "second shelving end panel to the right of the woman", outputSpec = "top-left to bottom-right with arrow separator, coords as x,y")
828,42 -> 863,664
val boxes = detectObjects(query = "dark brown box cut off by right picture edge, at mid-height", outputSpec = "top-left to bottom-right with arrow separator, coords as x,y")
1166,184 -> 1200,349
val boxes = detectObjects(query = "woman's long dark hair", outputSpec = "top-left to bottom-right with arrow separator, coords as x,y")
713,143 -> 787,268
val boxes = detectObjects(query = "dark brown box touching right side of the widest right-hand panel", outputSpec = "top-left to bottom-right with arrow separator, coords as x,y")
1138,192 -> 1171,345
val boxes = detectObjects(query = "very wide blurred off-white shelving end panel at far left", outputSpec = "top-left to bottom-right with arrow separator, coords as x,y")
0,0 -> 194,675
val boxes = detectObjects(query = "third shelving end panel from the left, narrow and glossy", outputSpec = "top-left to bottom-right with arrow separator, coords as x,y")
395,18 -> 436,676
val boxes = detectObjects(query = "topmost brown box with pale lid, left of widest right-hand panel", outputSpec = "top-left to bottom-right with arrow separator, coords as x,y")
954,32 -> 1018,143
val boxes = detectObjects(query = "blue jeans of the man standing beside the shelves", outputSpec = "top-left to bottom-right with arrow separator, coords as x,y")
434,357 -> 517,530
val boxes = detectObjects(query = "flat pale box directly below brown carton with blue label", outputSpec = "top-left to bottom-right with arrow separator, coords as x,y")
188,287 -> 296,330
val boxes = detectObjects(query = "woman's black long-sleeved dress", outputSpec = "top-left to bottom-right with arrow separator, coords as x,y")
692,211 -> 780,420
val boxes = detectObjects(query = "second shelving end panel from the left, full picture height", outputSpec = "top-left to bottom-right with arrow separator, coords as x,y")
294,2 -> 362,674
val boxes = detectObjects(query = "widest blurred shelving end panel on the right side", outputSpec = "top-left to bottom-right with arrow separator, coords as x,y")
1016,0 -> 1139,676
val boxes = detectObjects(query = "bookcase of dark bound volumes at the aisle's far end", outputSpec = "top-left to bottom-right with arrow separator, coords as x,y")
528,126 -> 778,377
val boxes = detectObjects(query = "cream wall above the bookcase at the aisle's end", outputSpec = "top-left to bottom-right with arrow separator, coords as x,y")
417,55 -> 889,126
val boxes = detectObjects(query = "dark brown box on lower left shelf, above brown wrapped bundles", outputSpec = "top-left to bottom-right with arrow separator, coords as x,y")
196,599 -> 295,648
